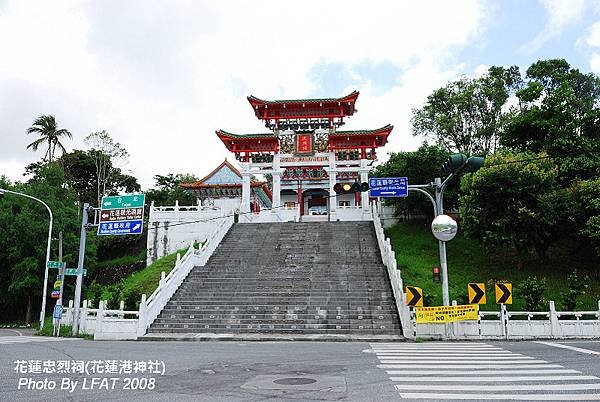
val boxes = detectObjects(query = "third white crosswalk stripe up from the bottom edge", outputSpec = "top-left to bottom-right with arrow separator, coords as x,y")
387,369 -> 599,382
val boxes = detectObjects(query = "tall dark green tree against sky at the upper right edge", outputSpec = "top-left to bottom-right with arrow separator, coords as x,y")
501,59 -> 600,188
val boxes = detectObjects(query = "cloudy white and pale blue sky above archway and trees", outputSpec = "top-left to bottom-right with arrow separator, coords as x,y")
0,0 -> 600,188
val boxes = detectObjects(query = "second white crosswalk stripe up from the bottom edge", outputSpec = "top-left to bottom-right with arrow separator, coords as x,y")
396,383 -> 600,391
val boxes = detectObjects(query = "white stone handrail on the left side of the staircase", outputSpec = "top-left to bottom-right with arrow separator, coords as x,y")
138,216 -> 233,336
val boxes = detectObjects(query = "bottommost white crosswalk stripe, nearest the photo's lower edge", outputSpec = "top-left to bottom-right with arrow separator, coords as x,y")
400,392 -> 600,401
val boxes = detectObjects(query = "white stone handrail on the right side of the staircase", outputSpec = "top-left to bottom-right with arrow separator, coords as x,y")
371,204 -> 414,338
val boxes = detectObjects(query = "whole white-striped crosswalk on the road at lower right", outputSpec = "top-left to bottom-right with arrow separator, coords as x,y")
371,343 -> 600,401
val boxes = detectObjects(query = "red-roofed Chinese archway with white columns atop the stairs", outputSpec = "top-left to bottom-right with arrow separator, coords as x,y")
216,91 -> 393,220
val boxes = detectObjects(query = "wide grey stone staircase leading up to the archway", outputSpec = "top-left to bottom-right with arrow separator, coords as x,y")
144,222 -> 402,340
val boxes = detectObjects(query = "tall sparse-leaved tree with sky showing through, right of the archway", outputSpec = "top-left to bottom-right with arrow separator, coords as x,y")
412,66 -> 521,155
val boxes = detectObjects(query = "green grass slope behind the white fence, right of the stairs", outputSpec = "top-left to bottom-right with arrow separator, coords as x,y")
386,222 -> 600,311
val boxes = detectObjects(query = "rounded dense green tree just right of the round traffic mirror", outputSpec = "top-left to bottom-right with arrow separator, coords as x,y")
460,152 -> 558,265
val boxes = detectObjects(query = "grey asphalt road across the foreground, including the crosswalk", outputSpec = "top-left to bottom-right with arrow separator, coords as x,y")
0,338 -> 600,401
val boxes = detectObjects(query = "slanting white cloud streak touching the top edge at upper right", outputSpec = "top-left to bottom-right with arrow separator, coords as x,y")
520,0 -> 589,53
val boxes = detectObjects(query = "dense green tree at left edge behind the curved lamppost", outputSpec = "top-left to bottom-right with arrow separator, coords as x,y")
0,163 -> 96,322
